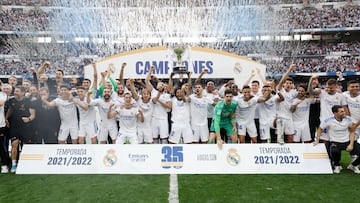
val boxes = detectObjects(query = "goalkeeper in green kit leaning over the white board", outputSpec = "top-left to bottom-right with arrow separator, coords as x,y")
209,89 -> 237,149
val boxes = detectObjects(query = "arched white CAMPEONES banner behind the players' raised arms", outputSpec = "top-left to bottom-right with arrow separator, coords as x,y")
84,47 -> 265,87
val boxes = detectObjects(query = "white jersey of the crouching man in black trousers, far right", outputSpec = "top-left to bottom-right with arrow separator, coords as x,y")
320,116 -> 354,142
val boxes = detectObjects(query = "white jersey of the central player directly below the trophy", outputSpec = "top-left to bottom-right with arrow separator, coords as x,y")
171,97 -> 190,124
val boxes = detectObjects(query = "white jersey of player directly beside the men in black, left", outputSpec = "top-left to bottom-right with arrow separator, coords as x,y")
53,98 -> 78,126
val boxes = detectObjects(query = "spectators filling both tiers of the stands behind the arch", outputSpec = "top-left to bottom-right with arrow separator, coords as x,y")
0,0 -> 360,75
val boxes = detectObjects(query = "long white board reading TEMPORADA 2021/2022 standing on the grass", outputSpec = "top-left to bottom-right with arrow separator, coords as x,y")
16,144 -> 332,174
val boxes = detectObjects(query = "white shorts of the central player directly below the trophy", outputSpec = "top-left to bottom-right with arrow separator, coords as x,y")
169,123 -> 193,144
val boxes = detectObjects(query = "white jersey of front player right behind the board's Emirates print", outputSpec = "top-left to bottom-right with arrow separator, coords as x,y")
116,107 -> 139,135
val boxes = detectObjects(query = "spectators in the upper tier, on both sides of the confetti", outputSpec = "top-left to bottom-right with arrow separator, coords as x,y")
0,1 -> 360,31
